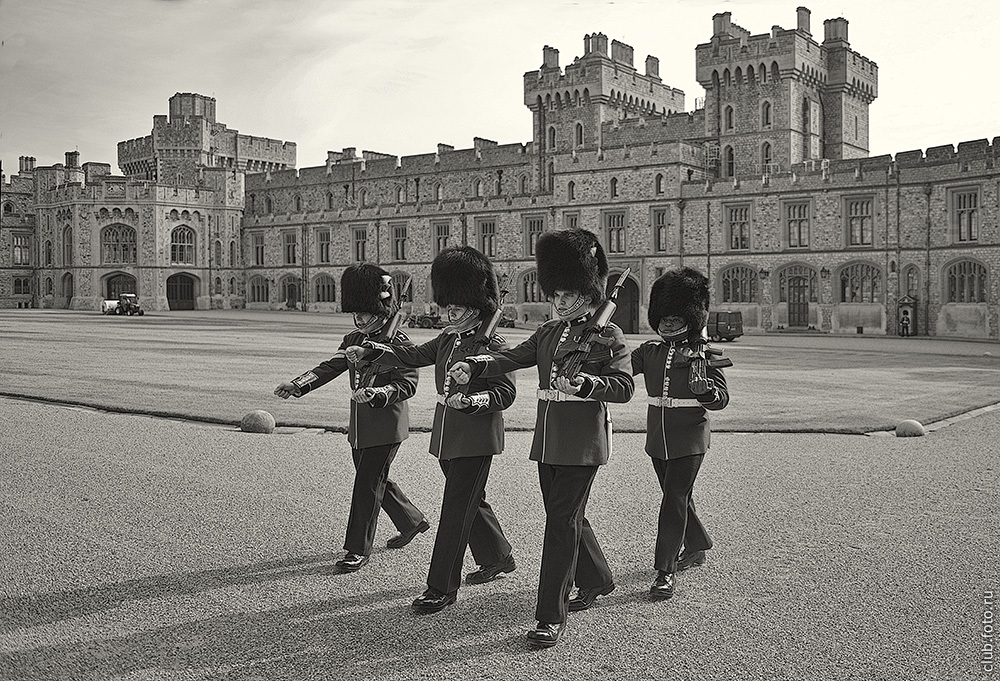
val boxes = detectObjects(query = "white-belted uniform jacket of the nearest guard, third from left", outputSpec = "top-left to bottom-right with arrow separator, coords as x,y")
466,315 -> 635,466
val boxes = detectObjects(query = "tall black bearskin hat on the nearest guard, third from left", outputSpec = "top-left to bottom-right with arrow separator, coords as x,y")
535,229 -> 608,304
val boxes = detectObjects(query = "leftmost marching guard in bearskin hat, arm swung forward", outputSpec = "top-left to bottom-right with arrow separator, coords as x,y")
274,263 -> 430,572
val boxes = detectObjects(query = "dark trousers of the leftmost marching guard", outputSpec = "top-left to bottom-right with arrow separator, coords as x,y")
344,442 -> 424,556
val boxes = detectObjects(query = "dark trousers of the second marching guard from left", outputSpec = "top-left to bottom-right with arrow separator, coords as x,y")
427,456 -> 511,593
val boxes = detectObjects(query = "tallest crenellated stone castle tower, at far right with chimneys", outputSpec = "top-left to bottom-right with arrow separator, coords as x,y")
696,7 -> 878,177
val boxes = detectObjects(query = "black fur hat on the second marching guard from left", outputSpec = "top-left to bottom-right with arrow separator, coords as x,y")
431,246 -> 500,318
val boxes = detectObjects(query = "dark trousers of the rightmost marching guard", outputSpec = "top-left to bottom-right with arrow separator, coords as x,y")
653,454 -> 712,572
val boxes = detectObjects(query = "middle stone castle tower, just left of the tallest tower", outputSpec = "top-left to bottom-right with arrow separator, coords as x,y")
524,33 -> 684,191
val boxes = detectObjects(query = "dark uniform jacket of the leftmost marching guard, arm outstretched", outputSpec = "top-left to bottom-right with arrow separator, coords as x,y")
292,330 -> 418,449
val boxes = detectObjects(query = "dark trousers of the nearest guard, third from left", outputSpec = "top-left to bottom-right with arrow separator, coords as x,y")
535,463 -> 614,622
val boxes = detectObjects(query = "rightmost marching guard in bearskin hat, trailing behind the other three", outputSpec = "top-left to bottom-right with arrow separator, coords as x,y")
632,267 -> 732,599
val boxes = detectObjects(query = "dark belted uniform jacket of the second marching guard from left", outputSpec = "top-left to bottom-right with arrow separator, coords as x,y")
365,326 -> 516,460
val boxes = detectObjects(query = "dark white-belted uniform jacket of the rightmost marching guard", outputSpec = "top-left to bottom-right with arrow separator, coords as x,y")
632,340 -> 729,459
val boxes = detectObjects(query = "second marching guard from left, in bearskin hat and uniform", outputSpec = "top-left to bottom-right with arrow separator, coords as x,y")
347,246 -> 515,612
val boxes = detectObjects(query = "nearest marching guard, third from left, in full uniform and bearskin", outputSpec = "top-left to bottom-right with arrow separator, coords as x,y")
450,229 -> 634,647
